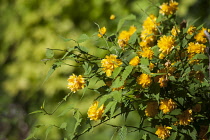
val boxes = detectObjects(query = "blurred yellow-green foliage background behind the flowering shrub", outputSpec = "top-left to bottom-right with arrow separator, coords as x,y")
0,0 -> 210,140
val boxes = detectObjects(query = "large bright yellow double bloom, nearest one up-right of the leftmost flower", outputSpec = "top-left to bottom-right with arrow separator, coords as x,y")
101,54 -> 122,77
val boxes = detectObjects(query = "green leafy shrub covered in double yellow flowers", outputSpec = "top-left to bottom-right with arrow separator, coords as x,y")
28,0 -> 210,140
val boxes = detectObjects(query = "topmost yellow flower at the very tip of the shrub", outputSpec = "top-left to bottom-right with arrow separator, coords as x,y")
160,0 -> 179,15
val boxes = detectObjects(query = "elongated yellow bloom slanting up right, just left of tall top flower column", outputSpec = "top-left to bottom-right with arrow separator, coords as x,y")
117,26 -> 136,49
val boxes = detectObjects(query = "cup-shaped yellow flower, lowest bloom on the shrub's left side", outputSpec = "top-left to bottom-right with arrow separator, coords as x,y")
87,101 -> 105,121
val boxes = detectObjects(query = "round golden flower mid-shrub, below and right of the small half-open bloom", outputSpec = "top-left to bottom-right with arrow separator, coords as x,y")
136,73 -> 152,88
